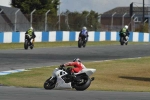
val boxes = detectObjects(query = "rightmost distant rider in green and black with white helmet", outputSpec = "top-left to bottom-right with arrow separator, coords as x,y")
119,25 -> 130,42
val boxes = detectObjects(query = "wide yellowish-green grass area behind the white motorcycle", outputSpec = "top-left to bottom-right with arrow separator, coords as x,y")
0,57 -> 150,92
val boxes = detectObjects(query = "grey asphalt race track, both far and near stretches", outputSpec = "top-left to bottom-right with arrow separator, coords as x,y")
0,45 -> 150,100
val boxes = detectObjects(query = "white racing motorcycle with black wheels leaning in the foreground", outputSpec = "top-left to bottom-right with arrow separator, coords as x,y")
44,67 -> 96,91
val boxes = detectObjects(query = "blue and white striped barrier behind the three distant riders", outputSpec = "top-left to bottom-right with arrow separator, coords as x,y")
0,31 -> 150,43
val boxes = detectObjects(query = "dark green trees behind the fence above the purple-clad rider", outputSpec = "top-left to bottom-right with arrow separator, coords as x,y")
61,10 -> 100,31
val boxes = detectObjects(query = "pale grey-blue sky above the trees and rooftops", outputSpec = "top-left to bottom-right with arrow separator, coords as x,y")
0,0 -> 150,13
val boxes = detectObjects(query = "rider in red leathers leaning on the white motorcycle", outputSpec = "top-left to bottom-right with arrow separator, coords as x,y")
60,58 -> 86,79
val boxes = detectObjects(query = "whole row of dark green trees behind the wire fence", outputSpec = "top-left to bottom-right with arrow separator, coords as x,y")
11,0 -> 100,31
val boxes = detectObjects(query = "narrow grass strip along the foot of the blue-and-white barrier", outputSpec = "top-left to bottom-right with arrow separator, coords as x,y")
0,41 -> 149,49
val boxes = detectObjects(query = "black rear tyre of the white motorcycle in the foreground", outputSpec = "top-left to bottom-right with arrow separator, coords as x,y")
74,76 -> 91,91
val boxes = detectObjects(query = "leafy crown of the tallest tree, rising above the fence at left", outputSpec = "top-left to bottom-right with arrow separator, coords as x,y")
11,0 -> 59,15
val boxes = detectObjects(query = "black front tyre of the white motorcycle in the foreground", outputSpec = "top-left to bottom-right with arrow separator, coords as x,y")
44,77 -> 57,90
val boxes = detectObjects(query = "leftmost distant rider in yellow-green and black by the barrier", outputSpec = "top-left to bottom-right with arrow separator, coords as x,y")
25,27 -> 36,46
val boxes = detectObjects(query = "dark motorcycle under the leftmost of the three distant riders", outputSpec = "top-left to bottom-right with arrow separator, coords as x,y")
24,34 -> 33,50
